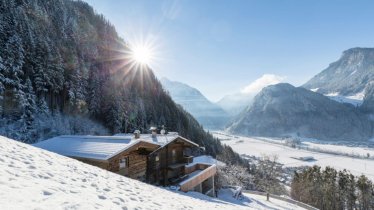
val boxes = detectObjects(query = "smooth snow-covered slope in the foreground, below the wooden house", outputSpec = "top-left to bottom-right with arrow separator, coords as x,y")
0,136 -> 248,210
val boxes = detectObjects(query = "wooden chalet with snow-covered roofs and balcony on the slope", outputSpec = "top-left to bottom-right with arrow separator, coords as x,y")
34,131 -> 216,196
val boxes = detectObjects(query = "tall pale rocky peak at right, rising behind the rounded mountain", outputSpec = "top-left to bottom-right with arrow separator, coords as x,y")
303,48 -> 374,98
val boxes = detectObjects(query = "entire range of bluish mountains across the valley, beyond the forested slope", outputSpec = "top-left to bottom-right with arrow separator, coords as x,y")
161,48 -> 374,141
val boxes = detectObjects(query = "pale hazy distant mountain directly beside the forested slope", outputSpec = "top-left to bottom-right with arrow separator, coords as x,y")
161,78 -> 229,129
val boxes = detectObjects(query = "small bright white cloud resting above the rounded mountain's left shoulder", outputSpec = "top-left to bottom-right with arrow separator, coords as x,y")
241,74 -> 286,94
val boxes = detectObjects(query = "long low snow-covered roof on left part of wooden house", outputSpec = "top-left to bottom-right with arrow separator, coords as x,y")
34,136 -> 159,160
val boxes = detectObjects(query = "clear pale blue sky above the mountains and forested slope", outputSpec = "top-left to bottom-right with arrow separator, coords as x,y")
83,0 -> 374,101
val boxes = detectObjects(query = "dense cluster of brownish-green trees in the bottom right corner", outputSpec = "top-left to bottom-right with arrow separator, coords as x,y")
291,166 -> 374,210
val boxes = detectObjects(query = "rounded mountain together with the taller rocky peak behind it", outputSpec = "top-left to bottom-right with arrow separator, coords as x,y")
227,48 -> 374,141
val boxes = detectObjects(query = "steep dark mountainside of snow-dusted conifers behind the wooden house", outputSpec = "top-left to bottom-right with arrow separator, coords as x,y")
0,0 -> 244,162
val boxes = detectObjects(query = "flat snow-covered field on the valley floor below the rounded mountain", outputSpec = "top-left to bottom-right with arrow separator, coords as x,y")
213,132 -> 374,180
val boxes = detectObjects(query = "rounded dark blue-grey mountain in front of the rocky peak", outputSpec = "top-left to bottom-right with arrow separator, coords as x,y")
228,84 -> 373,141
